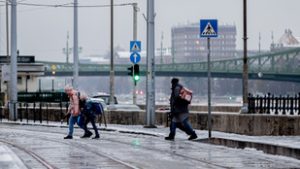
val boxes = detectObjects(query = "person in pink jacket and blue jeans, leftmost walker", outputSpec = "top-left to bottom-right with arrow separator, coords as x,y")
64,85 -> 79,139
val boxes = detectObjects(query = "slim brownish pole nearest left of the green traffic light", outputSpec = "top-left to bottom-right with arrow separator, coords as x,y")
109,0 -> 115,105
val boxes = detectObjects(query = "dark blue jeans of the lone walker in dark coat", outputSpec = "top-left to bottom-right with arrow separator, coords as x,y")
170,118 -> 195,137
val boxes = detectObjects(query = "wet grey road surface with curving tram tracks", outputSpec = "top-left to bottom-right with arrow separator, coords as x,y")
0,124 -> 300,169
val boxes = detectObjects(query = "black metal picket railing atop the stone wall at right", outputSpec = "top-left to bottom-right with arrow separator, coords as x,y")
248,93 -> 300,115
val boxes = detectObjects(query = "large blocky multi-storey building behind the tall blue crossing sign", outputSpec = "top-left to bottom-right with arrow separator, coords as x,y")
171,23 -> 236,63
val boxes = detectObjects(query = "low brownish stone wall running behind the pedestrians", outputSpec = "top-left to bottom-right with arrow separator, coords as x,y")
2,108 -> 300,136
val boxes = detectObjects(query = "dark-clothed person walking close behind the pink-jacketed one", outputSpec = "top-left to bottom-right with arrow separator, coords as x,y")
80,93 -> 103,139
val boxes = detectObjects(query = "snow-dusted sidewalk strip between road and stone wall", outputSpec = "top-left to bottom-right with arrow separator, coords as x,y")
2,120 -> 300,160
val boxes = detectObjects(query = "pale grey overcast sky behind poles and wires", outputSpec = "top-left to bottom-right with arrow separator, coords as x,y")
0,0 -> 300,61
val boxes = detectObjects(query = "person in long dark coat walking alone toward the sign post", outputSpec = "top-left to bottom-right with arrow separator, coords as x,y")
165,78 -> 198,140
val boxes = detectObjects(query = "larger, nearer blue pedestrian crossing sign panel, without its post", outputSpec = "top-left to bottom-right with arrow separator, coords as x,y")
200,19 -> 218,38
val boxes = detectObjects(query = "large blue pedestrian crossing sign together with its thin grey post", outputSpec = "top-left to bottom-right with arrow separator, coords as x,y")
200,19 -> 218,138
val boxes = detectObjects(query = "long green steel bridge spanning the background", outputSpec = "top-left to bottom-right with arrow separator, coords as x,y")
40,48 -> 300,82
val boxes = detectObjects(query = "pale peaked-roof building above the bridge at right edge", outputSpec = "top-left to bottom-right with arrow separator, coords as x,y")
270,29 -> 300,51
